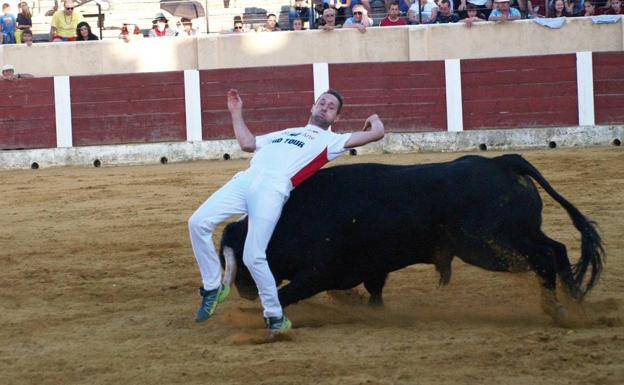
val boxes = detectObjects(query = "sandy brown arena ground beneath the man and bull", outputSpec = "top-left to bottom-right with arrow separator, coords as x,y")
0,147 -> 624,385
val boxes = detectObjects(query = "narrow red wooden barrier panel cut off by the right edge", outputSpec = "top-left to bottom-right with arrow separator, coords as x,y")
592,52 -> 624,124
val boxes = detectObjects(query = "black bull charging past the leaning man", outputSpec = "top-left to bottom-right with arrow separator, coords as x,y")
220,155 -> 604,318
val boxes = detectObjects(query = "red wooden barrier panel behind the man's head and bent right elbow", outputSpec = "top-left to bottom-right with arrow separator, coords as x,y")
329,61 -> 446,132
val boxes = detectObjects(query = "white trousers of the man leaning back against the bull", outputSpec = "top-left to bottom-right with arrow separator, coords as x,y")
189,169 -> 292,317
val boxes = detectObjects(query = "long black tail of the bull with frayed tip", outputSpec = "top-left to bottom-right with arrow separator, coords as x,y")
495,154 -> 605,301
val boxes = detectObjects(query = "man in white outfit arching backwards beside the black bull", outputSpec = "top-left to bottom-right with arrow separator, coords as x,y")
189,90 -> 384,333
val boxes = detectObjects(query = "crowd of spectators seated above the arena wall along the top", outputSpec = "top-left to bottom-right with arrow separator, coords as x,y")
0,0 -> 624,45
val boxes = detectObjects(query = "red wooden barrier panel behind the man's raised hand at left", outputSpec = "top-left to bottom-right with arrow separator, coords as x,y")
200,65 -> 314,140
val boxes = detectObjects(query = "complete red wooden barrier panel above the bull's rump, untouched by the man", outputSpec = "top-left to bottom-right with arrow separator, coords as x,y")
461,54 -> 578,130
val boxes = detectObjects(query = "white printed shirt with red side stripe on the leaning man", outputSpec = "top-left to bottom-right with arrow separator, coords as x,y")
251,124 -> 351,187
